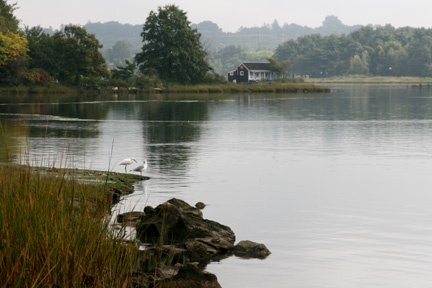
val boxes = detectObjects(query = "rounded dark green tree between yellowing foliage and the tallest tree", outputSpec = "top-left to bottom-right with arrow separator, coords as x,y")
53,25 -> 109,85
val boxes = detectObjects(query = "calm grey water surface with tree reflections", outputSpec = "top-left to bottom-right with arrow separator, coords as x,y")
0,86 -> 432,288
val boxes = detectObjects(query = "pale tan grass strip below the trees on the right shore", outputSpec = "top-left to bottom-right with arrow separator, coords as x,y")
305,75 -> 432,85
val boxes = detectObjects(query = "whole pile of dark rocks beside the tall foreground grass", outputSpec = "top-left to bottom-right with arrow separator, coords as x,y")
133,198 -> 270,288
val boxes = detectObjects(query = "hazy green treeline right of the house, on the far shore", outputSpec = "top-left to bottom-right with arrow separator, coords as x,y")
273,25 -> 432,78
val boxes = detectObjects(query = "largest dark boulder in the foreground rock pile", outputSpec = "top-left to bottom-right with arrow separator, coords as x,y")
136,198 -> 235,261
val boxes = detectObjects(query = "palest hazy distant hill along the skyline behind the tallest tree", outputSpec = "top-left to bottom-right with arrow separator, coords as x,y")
78,16 -> 362,51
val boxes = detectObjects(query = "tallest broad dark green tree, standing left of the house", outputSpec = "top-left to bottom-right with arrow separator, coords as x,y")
135,5 -> 211,84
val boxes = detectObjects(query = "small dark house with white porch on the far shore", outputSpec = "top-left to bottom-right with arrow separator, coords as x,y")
228,62 -> 277,83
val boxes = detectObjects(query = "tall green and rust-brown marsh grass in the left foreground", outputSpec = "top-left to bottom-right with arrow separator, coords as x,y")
0,164 -> 136,287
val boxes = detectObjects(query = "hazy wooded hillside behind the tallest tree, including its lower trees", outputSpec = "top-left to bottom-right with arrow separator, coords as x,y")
79,16 -> 361,76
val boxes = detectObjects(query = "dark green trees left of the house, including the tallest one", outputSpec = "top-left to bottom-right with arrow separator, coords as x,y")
0,0 -> 225,91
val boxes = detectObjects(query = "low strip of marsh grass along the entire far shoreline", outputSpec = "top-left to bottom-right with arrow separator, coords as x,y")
4,75 -> 432,95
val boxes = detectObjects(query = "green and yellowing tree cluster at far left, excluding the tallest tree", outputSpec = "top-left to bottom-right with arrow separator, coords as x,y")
0,0 -> 110,86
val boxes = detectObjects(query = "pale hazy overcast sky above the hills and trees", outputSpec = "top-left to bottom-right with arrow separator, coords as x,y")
13,0 -> 432,32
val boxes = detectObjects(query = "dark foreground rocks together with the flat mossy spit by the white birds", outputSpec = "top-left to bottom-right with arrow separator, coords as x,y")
32,167 -> 271,288
